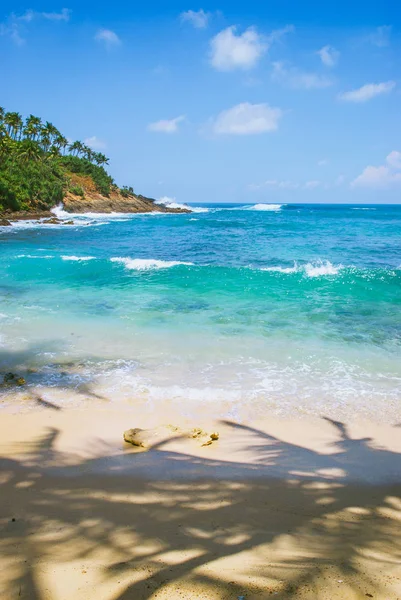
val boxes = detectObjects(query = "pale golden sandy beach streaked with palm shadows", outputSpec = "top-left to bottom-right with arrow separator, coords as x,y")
0,404 -> 401,600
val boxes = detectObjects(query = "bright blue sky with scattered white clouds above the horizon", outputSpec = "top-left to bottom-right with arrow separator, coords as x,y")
0,0 -> 401,203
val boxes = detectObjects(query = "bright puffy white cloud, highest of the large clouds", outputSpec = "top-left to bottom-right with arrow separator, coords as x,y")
210,26 -> 268,71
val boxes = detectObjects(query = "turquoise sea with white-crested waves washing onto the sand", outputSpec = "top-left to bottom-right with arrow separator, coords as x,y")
0,204 -> 401,421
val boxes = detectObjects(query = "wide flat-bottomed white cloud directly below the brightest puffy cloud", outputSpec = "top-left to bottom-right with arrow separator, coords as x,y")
213,102 -> 283,135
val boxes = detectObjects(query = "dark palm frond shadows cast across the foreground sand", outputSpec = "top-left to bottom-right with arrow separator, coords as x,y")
0,422 -> 401,600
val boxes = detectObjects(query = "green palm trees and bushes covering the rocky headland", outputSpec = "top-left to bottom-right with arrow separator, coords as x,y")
0,107 -> 115,211
